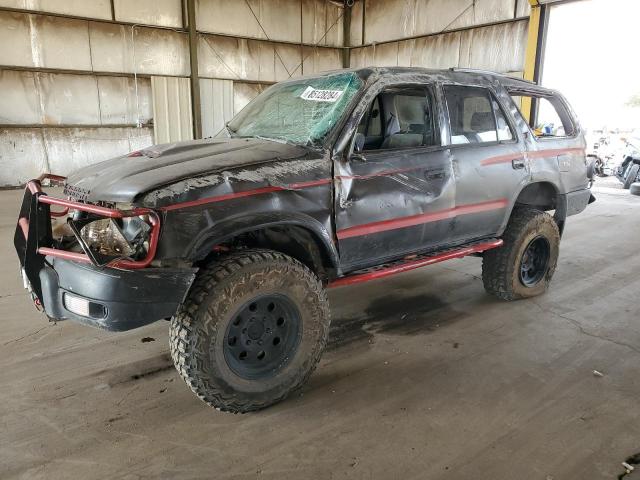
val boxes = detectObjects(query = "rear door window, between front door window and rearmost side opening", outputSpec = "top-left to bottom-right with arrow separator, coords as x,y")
444,86 -> 514,145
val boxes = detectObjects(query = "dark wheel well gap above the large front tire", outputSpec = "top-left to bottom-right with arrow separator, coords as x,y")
203,225 -> 335,281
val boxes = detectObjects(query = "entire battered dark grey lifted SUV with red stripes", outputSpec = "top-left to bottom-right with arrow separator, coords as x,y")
15,68 -> 593,412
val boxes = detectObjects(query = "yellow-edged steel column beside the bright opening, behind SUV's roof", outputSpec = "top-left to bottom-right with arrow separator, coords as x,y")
522,0 -> 549,125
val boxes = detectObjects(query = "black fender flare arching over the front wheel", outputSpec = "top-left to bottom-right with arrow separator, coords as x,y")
185,212 -> 340,268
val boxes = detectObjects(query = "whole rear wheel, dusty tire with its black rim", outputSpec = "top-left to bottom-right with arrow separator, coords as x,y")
482,208 -> 560,300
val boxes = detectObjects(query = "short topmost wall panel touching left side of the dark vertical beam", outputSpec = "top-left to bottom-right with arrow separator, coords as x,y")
114,0 -> 182,28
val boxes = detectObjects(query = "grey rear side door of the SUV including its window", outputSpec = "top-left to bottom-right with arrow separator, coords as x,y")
443,85 -> 530,243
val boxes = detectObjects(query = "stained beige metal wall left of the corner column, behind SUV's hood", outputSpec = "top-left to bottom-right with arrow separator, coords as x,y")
0,0 -> 343,186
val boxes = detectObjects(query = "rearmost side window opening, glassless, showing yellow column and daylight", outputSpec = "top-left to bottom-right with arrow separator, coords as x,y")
511,92 -> 575,138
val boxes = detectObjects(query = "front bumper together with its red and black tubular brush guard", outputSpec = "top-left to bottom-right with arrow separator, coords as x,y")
14,175 -> 197,331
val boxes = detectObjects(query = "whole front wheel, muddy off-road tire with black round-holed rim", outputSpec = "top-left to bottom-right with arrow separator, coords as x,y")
170,250 -> 330,413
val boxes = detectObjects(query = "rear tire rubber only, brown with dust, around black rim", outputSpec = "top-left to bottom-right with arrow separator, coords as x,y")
482,207 -> 560,301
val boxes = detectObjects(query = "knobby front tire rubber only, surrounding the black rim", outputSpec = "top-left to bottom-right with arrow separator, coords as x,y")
169,250 -> 330,413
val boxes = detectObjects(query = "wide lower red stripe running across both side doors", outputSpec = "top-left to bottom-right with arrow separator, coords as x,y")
336,198 -> 508,240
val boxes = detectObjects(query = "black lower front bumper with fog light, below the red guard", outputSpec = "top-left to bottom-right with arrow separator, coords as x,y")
39,257 -> 197,331
